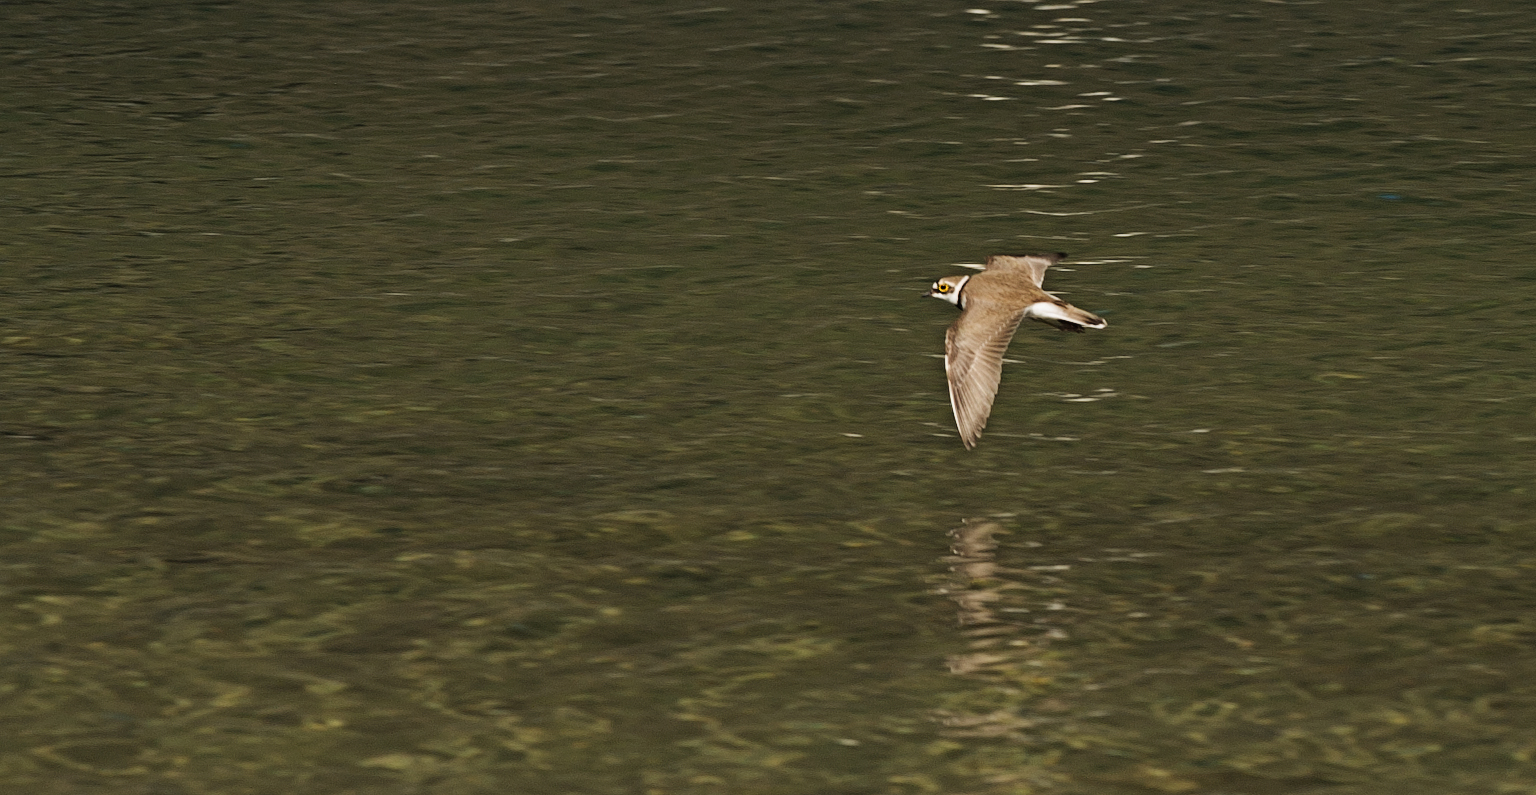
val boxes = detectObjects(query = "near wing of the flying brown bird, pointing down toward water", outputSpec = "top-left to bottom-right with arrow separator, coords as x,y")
945,307 -> 1025,450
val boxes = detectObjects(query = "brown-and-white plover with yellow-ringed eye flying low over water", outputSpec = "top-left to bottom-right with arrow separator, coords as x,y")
925,253 -> 1109,450
